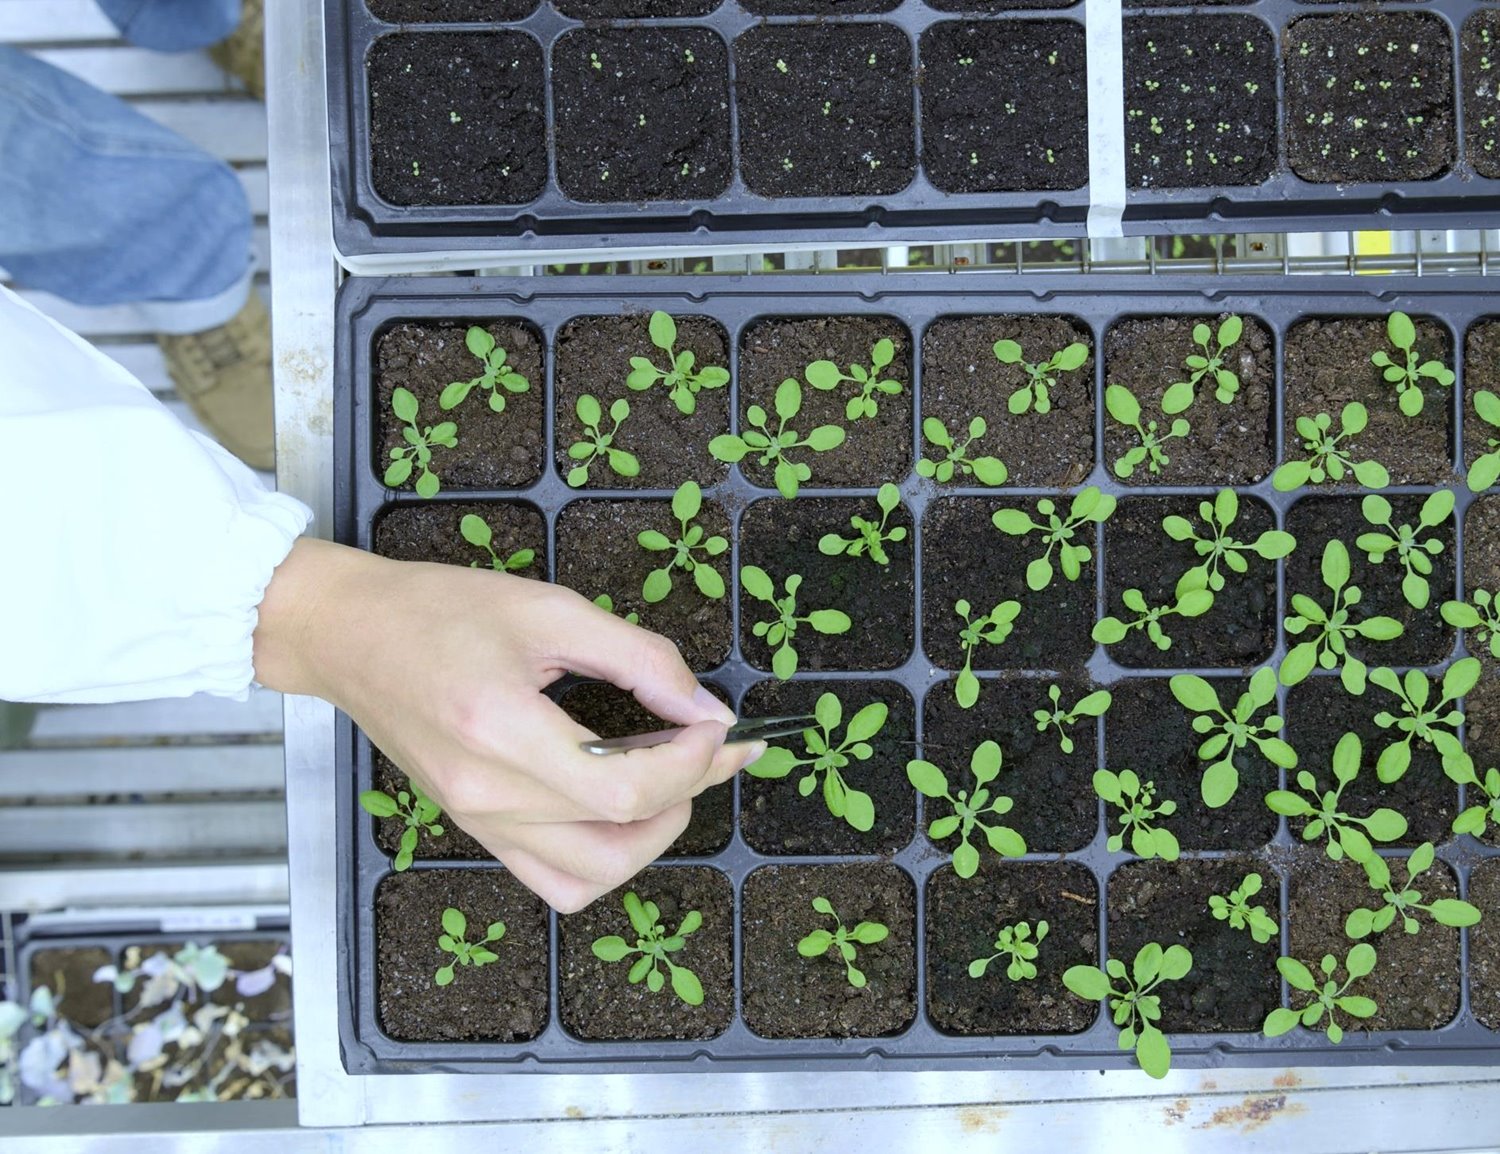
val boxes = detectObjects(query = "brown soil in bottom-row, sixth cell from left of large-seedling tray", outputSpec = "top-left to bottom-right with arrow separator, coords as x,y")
1287,851 -> 1461,1034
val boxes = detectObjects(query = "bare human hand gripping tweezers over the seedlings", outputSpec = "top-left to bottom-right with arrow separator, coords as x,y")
255,539 -> 765,912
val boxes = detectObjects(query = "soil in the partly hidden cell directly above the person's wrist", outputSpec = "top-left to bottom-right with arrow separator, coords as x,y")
374,501 -> 548,570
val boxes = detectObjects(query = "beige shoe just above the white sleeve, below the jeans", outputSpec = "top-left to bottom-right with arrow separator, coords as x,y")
156,287 -> 276,470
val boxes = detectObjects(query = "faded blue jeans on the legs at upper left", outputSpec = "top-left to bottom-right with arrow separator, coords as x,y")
0,0 -> 251,310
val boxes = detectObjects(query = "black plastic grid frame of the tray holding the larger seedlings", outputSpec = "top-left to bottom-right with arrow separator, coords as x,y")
335,273 -> 1500,1073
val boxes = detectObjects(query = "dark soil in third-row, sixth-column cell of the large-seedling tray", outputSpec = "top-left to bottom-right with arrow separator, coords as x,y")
1286,675 -> 1458,846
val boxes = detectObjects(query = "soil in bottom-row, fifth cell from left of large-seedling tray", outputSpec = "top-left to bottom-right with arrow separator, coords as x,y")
1107,857 -> 1281,1034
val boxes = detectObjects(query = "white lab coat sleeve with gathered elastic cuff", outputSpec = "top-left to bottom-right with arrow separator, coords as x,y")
0,288 -> 312,702
